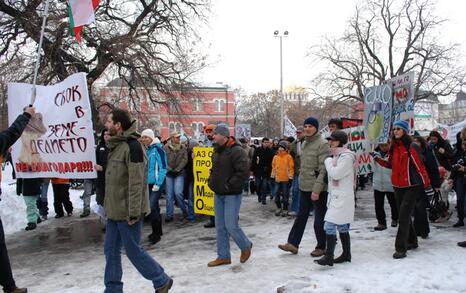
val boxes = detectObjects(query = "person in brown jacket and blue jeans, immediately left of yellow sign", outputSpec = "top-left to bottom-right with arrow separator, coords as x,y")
164,132 -> 188,223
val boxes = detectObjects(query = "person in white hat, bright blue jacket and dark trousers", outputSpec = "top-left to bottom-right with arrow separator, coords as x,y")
141,129 -> 167,244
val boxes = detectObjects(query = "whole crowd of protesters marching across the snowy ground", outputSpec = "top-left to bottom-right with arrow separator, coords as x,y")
0,107 -> 466,293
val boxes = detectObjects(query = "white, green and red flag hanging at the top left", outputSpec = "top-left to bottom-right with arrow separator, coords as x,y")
68,0 -> 100,42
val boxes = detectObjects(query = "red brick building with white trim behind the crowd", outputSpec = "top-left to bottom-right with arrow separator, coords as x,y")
95,80 -> 235,139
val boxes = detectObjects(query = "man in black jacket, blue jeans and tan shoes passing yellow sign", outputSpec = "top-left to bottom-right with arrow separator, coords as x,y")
208,125 -> 252,267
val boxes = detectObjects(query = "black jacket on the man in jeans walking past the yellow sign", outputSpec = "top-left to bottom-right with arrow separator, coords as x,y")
209,137 -> 249,195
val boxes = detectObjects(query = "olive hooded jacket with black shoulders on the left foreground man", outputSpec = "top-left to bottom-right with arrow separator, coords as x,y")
104,123 -> 150,221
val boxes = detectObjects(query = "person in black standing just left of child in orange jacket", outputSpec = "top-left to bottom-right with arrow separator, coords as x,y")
251,137 -> 274,204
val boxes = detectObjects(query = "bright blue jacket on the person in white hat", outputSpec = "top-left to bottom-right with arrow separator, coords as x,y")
147,144 -> 167,187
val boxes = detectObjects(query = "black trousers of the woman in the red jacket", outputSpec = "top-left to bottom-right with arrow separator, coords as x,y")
395,186 -> 418,252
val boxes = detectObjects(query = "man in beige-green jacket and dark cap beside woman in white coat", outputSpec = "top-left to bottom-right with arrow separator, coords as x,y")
278,117 -> 329,257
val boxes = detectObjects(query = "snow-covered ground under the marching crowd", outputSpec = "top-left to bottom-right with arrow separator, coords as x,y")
0,163 -> 466,293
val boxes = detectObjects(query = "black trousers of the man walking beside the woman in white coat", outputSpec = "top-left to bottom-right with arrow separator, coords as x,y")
288,191 -> 328,250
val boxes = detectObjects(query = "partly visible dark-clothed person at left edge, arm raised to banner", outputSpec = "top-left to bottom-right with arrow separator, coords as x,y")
0,107 -> 35,293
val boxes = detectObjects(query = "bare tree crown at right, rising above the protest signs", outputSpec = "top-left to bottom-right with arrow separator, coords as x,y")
311,0 -> 466,102
